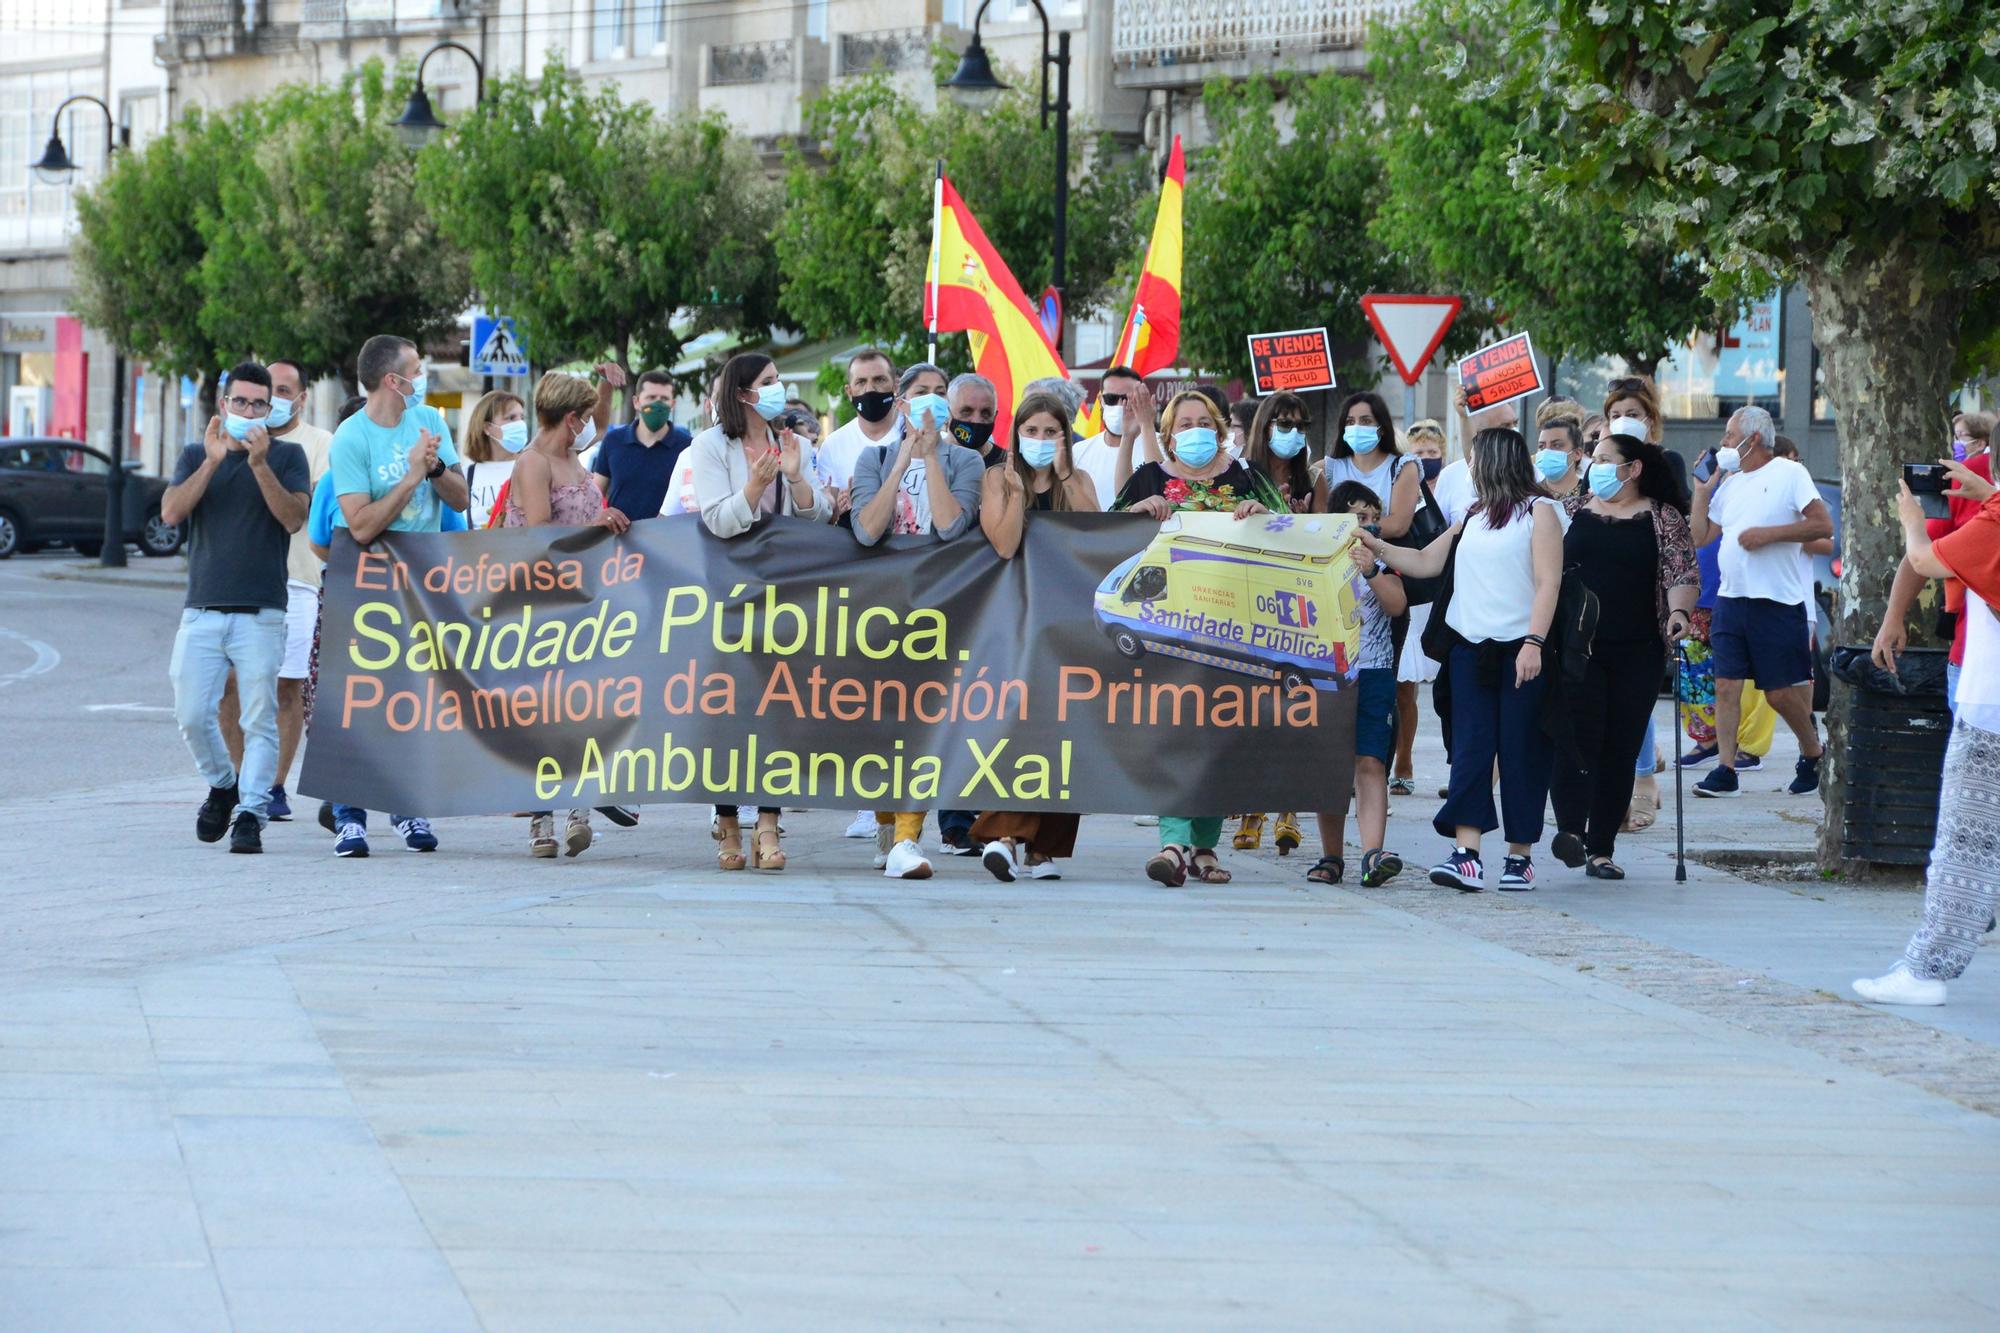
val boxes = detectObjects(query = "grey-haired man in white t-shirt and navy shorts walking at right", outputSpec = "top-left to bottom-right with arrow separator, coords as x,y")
1690,406 -> 1834,797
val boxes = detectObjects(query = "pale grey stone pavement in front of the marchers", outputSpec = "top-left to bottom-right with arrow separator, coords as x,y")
0,700 -> 2000,1329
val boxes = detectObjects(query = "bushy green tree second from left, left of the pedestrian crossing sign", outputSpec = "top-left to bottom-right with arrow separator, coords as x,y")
198,60 -> 472,388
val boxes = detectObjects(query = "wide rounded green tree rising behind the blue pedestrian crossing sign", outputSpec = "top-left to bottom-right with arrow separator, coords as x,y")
418,58 -> 778,386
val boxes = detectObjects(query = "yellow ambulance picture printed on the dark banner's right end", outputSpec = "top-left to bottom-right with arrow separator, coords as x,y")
1096,512 -> 1362,691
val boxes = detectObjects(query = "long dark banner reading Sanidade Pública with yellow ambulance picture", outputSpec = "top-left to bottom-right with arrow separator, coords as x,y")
300,514 -> 1360,817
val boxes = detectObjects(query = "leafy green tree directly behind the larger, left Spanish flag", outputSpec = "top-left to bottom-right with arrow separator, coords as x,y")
776,76 -> 1152,364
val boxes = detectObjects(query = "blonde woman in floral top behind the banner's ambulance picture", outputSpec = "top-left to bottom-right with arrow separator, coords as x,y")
1112,390 -> 1286,889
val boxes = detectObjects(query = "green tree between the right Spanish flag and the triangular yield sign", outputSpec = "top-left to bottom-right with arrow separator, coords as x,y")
1180,70 -> 1432,380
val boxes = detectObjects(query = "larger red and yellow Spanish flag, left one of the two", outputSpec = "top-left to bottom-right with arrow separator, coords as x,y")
924,172 -> 1070,448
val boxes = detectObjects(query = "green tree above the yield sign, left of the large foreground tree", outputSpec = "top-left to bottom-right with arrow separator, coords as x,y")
1368,0 -> 1726,370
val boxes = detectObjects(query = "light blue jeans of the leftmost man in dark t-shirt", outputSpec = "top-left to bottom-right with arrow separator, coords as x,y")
166,606 -> 284,827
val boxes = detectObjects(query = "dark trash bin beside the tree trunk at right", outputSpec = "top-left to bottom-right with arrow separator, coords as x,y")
1830,644 -> 1952,865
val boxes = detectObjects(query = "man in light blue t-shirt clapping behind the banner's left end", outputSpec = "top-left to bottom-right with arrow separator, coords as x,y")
328,334 -> 468,857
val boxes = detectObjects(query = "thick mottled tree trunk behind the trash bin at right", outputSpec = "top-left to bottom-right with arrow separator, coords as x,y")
1790,246 -> 1964,869
